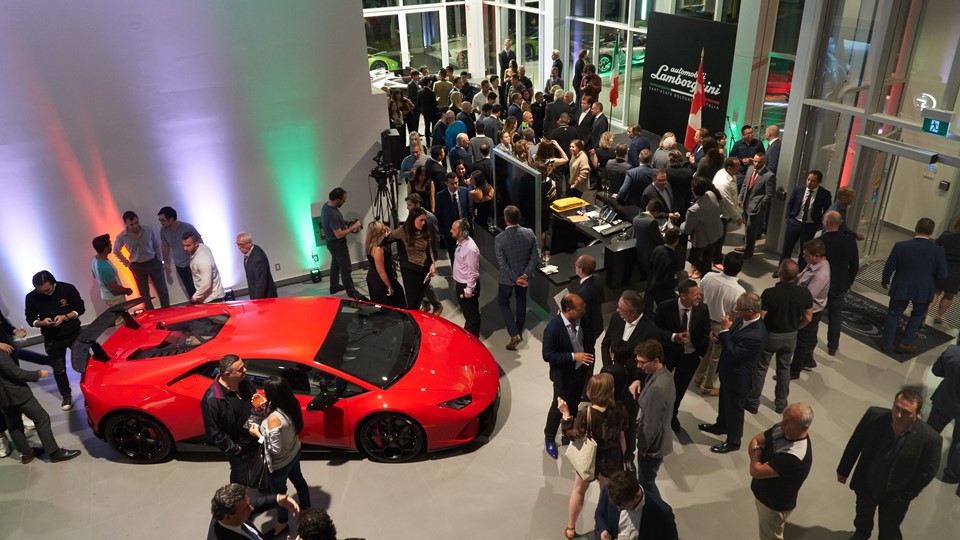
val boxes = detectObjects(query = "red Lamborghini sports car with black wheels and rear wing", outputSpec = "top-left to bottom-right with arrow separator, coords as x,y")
73,297 -> 500,463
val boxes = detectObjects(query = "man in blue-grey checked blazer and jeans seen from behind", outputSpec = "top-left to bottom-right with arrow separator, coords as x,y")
494,205 -> 540,351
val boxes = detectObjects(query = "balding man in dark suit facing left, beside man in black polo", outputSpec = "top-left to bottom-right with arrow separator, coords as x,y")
697,293 -> 767,454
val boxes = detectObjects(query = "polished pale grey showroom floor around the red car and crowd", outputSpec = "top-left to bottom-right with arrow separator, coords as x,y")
0,230 -> 960,540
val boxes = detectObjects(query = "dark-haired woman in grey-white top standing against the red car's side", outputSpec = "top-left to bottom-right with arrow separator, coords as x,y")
250,376 -> 310,537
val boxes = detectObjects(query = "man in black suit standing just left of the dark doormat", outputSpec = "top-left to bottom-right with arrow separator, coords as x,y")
820,210 -> 860,356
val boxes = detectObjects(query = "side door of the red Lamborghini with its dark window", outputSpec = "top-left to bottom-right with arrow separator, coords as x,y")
244,358 -> 366,448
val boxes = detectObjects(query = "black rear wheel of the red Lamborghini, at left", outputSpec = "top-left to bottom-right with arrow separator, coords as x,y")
104,411 -> 173,463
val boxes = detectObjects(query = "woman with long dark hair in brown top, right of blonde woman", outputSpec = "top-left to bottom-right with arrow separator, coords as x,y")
384,208 -> 437,309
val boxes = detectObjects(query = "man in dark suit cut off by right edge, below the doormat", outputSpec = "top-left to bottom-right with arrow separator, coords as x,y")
927,345 -> 960,496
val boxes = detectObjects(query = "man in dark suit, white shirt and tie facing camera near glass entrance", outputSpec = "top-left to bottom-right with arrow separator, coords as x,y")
767,167 -> 833,279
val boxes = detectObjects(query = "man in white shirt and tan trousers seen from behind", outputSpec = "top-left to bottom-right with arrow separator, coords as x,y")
693,252 -> 746,396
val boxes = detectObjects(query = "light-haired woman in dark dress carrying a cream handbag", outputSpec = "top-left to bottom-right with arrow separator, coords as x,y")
557,373 -> 628,538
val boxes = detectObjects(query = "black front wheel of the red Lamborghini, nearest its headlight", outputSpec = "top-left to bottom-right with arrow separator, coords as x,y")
359,413 -> 426,463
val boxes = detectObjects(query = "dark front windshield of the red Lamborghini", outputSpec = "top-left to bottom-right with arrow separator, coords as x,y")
313,301 -> 420,388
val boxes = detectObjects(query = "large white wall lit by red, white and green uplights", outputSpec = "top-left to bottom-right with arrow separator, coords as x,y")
0,0 -> 387,325
